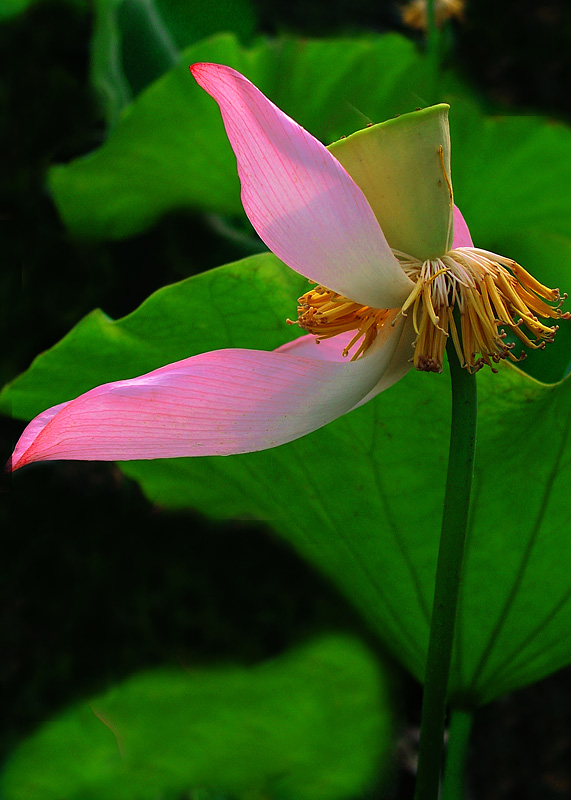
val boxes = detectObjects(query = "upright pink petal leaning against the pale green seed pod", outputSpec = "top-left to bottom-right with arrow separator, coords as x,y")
190,64 -> 411,308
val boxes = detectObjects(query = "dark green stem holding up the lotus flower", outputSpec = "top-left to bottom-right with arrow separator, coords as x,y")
414,337 -> 476,800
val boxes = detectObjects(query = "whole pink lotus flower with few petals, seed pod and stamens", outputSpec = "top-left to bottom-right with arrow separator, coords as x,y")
11,64 -> 561,476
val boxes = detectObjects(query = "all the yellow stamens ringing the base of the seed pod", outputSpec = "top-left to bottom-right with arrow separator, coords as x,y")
297,247 -> 571,372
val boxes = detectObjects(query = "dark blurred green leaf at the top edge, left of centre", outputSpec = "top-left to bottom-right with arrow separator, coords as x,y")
91,0 -> 255,125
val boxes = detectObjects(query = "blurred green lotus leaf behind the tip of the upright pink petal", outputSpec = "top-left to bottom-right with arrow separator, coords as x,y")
50,34 -> 462,238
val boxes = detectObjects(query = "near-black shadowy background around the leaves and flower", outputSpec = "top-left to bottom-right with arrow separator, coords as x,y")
0,0 -> 571,800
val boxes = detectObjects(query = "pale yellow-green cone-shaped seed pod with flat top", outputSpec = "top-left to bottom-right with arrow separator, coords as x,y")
329,103 -> 454,259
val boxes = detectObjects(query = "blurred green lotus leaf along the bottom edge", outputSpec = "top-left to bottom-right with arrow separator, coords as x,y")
0,636 -> 392,800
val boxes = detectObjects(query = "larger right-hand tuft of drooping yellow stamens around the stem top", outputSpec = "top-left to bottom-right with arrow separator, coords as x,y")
395,247 -> 569,372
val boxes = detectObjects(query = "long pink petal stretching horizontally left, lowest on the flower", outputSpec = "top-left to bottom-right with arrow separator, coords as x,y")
11,329 -> 404,470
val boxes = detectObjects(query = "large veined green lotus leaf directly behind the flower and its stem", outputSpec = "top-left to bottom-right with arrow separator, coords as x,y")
4,255 -> 571,704
